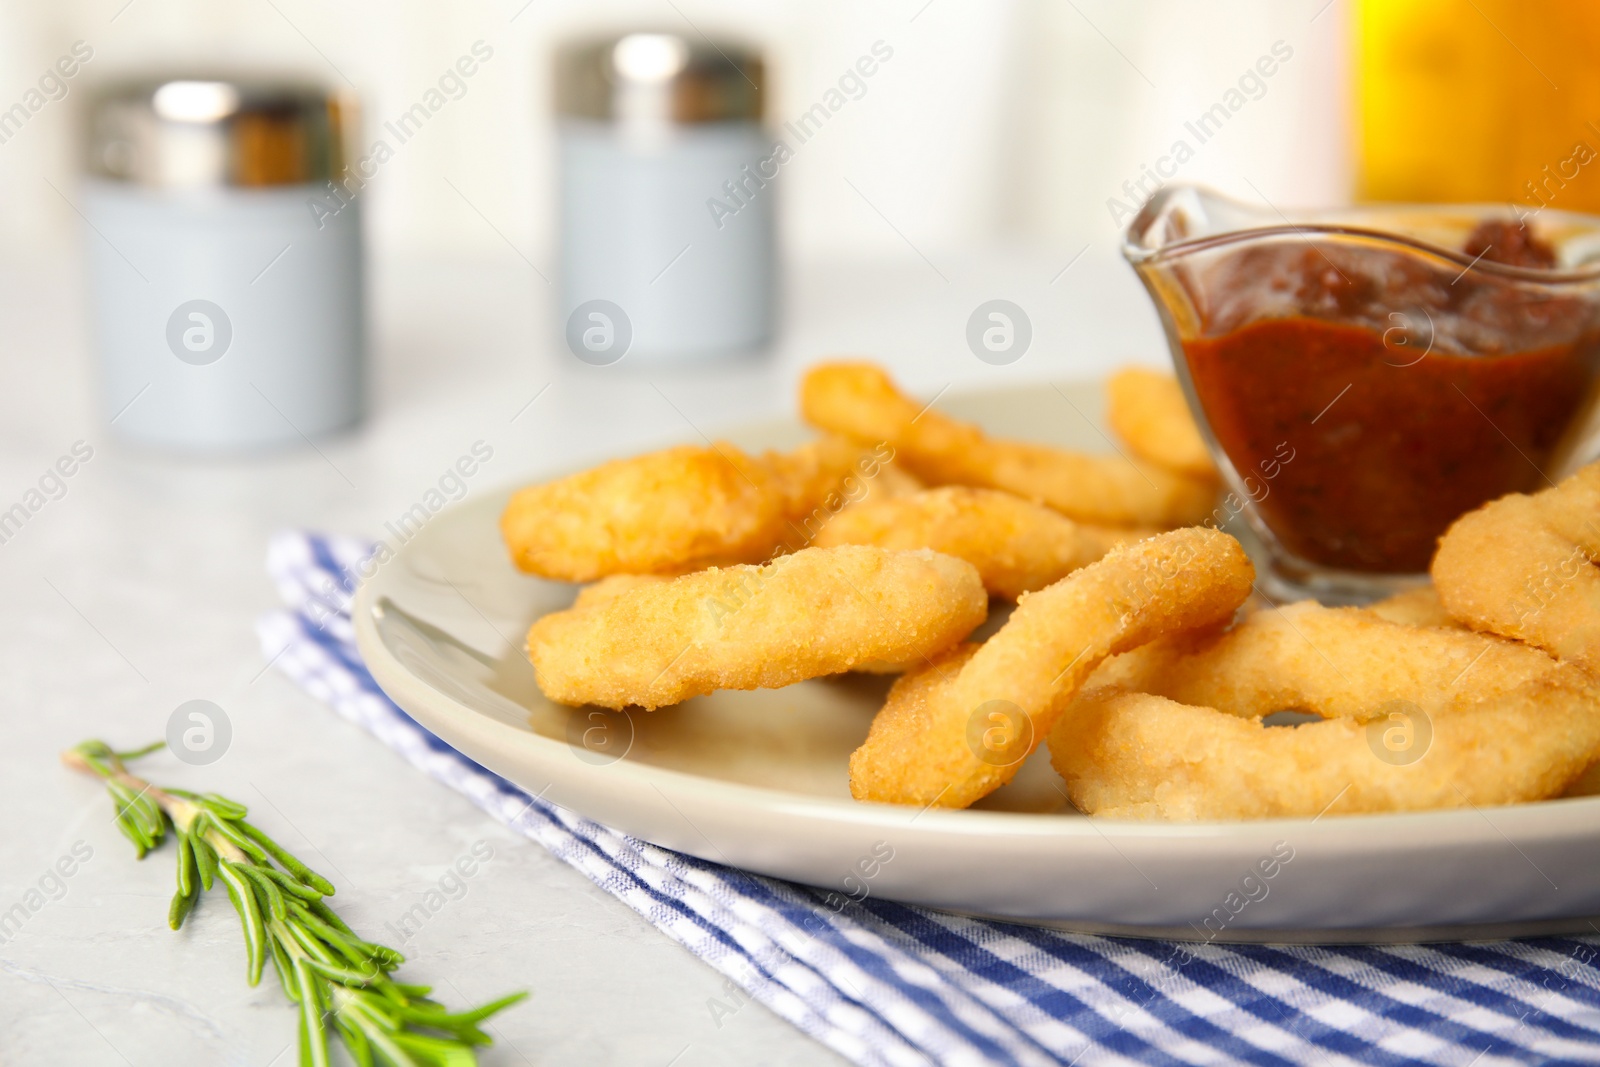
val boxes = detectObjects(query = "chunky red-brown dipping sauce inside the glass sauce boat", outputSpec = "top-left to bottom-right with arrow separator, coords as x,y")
1182,222 -> 1600,573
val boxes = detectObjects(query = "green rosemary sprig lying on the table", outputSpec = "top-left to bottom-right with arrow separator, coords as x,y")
61,741 -> 528,1067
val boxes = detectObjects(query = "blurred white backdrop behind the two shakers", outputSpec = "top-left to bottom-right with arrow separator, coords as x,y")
0,0 -> 1350,267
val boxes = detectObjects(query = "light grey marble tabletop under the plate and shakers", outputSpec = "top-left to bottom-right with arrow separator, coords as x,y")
0,245 -> 1165,1067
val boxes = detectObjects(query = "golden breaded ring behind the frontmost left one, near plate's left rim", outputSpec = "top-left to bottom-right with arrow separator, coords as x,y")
501,437 -> 875,582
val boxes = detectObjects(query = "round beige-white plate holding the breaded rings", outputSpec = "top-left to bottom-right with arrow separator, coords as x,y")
355,386 -> 1600,941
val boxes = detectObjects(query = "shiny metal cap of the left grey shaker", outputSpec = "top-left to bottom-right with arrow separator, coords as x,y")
85,77 -> 355,189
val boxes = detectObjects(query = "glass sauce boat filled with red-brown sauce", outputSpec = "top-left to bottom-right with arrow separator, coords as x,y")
1123,186 -> 1600,601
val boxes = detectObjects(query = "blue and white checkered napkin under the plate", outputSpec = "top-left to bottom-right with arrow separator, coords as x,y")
259,533 -> 1600,1067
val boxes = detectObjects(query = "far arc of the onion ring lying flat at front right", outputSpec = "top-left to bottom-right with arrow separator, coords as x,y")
1088,600 -> 1562,728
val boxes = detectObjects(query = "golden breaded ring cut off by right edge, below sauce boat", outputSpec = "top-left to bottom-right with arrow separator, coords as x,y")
1432,464 -> 1600,673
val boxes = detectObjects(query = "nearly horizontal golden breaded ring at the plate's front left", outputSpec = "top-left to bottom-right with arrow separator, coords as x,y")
528,545 -> 989,709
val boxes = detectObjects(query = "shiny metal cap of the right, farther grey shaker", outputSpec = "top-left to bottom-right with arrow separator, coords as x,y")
555,32 -> 766,125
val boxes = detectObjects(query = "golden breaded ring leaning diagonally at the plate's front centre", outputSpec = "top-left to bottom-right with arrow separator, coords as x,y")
850,528 -> 1254,808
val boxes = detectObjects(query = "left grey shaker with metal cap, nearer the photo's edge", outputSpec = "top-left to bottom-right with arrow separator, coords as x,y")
80,78 -> 365,451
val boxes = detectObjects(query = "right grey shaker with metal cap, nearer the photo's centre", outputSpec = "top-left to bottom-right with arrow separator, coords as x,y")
555,32 -> 781,365
